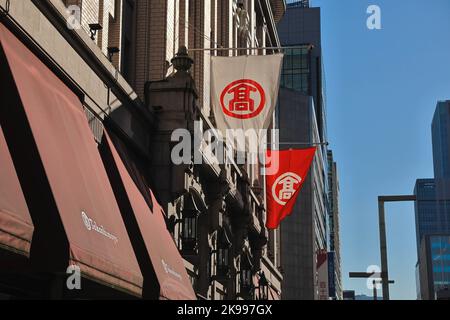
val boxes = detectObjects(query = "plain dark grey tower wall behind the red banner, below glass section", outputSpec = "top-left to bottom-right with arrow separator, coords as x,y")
278,88 -> 315,299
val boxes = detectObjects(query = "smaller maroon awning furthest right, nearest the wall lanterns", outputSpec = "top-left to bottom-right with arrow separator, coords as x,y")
101,132 -> 196,300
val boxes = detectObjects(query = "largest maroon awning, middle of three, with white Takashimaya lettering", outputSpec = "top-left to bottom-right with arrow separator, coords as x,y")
0,24 -> 143,296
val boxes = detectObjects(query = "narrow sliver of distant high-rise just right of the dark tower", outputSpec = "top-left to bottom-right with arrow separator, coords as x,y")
328,150 -> 342,300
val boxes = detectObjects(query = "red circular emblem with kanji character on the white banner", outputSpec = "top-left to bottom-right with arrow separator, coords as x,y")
220,79 -> 266,119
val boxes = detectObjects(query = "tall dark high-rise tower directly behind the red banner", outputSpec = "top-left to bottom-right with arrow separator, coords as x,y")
276,3 -> 329,300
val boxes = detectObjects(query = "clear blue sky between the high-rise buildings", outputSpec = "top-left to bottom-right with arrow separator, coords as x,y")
311,0 -> 450,299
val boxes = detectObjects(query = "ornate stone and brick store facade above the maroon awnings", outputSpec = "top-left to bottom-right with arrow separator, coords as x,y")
0,0 -> 285,299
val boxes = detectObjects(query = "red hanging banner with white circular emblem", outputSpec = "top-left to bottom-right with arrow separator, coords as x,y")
266,147 -> 316,229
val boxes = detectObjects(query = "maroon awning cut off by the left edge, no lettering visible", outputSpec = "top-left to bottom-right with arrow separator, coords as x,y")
0,126 -> 34,260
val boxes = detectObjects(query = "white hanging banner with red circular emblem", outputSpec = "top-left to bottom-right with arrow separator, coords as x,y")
211,54 -> 283,151
